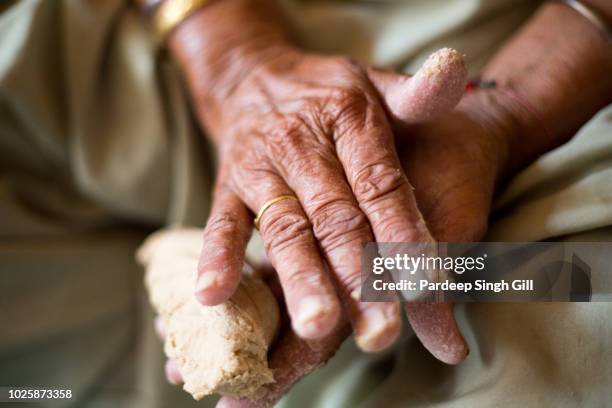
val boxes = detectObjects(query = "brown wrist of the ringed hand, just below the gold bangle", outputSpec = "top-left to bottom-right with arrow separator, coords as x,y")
168,0 -> 293,130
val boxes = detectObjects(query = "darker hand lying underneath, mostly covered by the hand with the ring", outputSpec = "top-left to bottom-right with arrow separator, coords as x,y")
213,91 -> 508,408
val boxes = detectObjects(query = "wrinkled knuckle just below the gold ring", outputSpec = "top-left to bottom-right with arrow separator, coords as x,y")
261,208 -> 312,254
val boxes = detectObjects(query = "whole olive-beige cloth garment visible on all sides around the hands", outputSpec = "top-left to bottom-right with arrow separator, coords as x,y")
0,0 -> 612,407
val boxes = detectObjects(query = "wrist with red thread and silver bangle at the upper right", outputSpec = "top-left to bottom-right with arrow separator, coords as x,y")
467,2 -> 612,176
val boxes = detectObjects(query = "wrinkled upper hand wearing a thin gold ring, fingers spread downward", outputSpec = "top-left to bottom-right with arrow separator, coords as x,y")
196,49 -> 466,351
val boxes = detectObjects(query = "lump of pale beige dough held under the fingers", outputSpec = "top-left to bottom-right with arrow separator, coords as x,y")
138,229 -> 279,399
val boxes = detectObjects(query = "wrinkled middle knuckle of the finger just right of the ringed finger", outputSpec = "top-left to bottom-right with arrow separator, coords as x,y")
312,200 -> 369,251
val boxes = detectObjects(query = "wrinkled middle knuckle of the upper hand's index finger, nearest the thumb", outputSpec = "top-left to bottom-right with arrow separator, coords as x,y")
353,162 -> 406,205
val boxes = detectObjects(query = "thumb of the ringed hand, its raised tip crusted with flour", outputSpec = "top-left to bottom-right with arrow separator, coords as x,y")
368,48 -> 467,125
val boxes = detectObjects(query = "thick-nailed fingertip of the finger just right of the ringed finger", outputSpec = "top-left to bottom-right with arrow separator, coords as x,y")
355,303 -> 402,352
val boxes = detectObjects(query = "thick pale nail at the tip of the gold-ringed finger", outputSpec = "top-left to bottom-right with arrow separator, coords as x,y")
293,296 -> 340,339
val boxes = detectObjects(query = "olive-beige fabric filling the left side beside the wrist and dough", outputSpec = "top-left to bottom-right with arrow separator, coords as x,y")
0,0 -> 213,407
